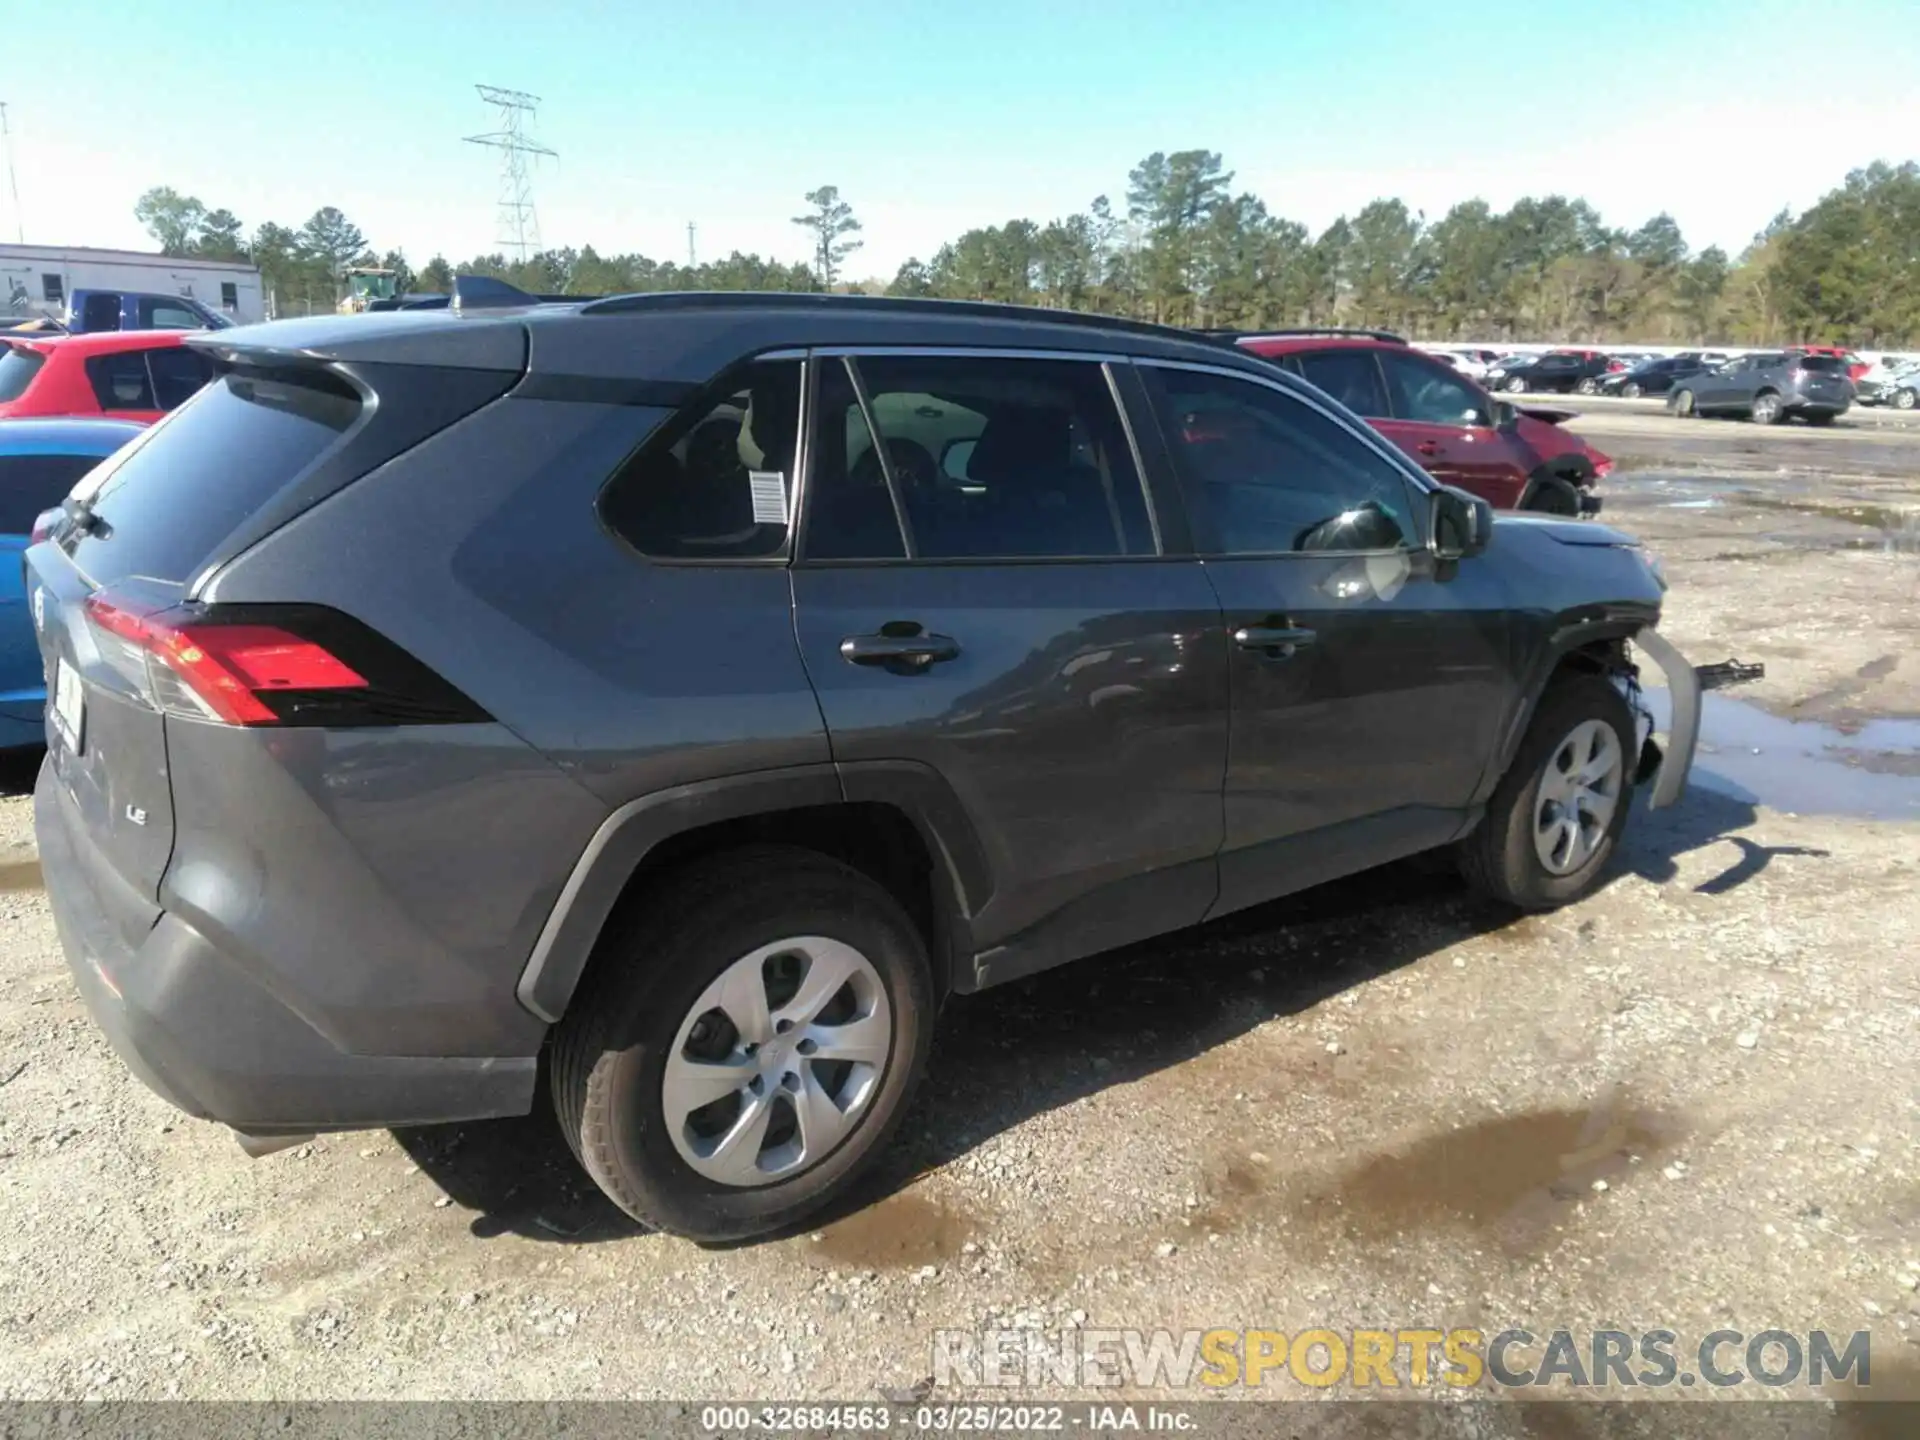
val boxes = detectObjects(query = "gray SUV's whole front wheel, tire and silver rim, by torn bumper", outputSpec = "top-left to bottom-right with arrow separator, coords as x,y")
1457,674 -> 1634,910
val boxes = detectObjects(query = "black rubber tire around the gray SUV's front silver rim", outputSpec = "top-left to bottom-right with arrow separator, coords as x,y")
1455,674 -> 1638,910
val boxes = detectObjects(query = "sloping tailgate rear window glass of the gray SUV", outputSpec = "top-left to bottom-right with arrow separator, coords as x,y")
65,368 -> 361,584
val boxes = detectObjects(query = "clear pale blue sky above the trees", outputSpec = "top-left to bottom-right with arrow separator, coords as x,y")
0,0 -> 1920,276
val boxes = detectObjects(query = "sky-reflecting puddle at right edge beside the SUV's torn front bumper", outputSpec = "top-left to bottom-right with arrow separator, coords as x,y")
1645,689 -> 1920,820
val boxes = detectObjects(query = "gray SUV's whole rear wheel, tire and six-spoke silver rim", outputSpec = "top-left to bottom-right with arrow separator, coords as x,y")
553,845 -> 933,1240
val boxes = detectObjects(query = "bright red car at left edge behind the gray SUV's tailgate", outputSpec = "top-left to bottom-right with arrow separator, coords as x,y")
0,330 -> 213,422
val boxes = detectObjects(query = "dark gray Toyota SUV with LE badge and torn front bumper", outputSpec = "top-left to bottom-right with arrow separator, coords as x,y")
27,290 -> 1697,1238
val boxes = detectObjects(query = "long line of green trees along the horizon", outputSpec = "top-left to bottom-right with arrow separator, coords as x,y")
134,150 -> 1920,348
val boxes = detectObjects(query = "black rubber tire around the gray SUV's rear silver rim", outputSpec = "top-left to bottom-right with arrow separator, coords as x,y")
551,845 -> 935,1240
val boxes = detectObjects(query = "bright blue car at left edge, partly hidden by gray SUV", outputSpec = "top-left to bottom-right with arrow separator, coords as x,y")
0,420 -> 146,751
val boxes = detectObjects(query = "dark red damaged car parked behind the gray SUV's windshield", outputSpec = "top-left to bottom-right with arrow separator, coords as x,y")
1235,330 -> 1613,515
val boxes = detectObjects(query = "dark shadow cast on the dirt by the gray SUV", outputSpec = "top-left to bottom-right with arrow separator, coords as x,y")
396,789 -> 1758,1242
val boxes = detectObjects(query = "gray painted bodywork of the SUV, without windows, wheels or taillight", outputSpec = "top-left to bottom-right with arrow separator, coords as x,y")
29,298 -> 1681,1133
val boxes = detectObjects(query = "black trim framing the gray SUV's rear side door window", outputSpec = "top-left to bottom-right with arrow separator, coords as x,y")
783,344 -> 1194,570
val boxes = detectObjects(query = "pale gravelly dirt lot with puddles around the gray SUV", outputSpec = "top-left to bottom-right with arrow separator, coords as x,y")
0,405 -> 1920,1413
